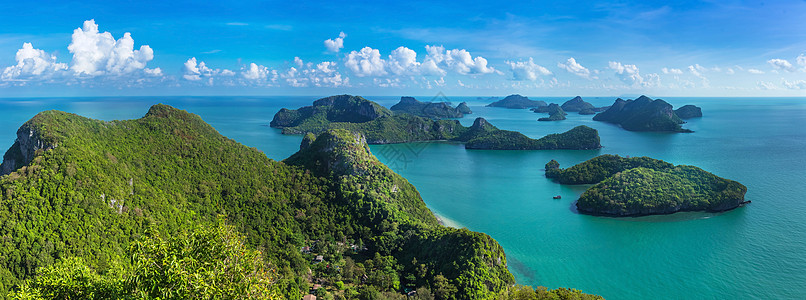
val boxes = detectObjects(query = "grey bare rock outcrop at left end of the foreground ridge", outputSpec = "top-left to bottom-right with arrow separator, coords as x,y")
0,122 -> 58,176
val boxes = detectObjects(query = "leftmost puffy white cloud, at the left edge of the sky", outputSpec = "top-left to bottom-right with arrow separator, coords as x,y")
0,43 -> 67,81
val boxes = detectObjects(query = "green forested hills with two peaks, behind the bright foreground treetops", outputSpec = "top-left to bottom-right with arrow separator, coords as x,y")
0,105 -> 524,299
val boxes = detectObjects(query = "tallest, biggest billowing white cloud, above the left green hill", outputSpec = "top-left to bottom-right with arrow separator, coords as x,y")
67,20 -> 154,76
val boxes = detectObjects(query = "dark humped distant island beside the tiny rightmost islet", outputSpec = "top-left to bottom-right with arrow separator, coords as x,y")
593,96 -> 693,132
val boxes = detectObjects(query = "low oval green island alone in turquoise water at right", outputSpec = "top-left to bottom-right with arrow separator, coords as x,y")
545,154 -> 749,217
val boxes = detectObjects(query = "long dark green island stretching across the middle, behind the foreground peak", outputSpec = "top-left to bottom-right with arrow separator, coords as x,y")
270,95 -> 601,150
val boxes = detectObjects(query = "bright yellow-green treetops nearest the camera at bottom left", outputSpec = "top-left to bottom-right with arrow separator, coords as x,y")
9,221 -> 279,299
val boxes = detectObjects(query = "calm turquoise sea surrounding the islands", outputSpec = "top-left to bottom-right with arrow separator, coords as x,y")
0,97 -> 806,299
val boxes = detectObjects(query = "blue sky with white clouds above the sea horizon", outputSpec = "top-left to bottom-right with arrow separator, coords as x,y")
0,0 -> 806,97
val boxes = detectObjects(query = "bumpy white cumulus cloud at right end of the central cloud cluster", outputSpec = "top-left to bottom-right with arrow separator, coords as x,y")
423,46 -> 495,75
